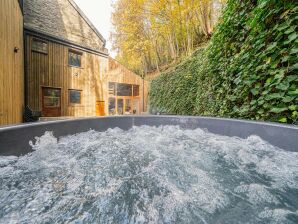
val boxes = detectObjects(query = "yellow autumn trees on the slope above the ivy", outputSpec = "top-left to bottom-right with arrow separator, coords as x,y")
111,0 -> 222,75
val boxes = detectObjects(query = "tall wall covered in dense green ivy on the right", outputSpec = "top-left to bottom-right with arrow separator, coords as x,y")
150,0 -> 298,124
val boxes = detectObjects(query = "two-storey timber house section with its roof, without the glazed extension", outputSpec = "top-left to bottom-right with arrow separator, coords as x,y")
24,0 -> 108,117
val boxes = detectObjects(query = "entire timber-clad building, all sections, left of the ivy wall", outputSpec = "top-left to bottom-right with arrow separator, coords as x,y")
0,0 -> 148,125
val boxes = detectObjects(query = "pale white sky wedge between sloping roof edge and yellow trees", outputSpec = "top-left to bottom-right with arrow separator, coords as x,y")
74,0 -> 115,57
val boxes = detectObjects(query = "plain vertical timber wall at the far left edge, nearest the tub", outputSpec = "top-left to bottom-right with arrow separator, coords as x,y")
0,0 -> 24,125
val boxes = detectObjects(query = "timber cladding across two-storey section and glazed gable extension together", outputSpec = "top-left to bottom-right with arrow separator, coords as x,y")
26,34 -> 148,117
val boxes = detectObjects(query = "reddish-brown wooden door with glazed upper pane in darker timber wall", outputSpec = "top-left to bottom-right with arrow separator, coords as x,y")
42,87 -> 61,117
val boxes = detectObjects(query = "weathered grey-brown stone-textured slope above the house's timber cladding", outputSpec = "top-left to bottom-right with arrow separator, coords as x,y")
24,0 -> 106,53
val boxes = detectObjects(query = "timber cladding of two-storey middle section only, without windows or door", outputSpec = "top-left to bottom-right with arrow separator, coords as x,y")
26,35 -> 107,116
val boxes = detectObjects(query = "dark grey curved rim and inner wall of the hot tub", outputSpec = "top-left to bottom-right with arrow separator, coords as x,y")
0,116 -> 298,156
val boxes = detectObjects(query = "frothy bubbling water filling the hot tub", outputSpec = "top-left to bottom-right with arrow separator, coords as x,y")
0,126 -> 298,224
